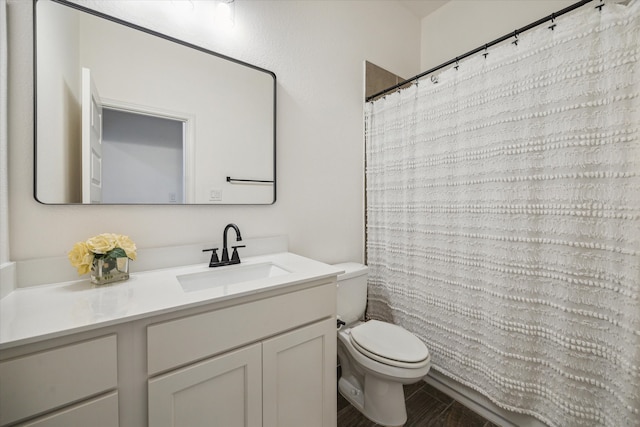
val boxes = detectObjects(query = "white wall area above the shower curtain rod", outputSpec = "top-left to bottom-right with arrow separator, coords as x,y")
420,0 -> 576,71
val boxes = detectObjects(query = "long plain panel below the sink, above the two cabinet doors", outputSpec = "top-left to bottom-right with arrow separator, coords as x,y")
147,281 -> 336,376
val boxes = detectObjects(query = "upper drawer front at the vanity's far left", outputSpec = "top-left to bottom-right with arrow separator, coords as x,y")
0,335 -> 118,425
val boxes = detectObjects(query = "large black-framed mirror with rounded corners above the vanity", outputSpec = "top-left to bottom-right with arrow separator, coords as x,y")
34,0 -> 276,204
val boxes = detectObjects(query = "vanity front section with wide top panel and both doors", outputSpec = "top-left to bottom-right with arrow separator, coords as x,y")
147,282 -> 336,427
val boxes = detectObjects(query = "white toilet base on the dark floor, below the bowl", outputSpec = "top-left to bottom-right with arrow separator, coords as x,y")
338,374 -> 407,427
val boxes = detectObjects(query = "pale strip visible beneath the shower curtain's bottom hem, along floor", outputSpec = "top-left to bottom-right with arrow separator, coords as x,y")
424,369 -> 547,427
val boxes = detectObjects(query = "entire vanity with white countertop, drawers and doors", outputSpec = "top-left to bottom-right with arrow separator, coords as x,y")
0,252 -> 339,427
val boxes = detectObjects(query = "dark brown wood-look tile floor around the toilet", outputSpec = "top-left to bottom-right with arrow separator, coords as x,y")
338,381 -> 497,427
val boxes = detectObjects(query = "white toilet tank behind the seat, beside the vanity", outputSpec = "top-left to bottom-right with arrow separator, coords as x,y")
335,262 -> 369,325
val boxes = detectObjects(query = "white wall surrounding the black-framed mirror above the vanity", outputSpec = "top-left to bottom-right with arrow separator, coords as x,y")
6,0 -> 420,268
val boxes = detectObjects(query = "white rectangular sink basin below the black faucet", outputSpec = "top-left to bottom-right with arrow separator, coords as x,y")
176,262 -> 289,292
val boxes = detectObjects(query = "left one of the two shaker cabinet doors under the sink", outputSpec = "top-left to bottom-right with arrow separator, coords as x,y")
149,343 -> 262,427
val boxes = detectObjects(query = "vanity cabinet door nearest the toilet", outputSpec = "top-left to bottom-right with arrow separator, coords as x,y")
262,319 -> 336,427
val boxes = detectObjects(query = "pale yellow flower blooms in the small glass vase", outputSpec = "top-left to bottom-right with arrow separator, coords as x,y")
69,233 -> 136,275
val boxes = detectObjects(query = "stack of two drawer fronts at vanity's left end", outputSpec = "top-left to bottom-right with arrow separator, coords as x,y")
0,335 -> 118,427
